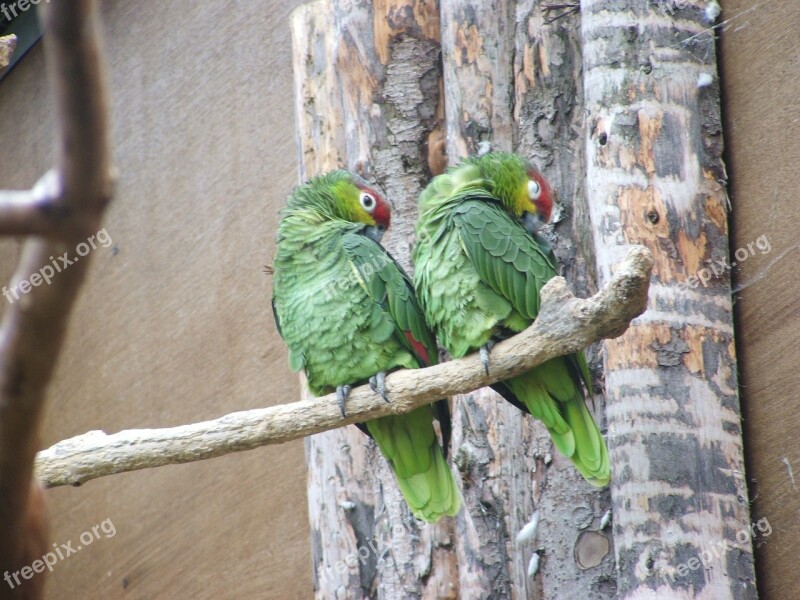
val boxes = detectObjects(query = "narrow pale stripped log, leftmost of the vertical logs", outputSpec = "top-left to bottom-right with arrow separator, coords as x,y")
291,7 -> 377,600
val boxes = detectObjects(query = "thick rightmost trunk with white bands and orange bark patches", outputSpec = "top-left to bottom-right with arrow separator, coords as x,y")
581,0 -> 758,599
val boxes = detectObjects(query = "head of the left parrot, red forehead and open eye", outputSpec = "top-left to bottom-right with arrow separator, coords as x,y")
287,170 -> 392,241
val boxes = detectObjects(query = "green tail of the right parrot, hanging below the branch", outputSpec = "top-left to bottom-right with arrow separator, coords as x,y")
498,357 -> 611,487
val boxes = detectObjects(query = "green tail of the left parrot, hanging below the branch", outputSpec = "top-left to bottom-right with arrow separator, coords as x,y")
365,406 -> 461,523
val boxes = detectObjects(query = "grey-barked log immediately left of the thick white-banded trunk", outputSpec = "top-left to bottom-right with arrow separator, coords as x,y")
513,0 -> 616,599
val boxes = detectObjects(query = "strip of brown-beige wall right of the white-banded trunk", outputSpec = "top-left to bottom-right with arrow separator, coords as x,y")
721,0 -> 800,600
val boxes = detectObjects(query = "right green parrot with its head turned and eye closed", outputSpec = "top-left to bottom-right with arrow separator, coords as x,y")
412,152 -> 611,487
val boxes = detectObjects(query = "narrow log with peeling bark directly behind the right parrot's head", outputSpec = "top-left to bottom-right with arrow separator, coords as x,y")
441,0 -> 520,598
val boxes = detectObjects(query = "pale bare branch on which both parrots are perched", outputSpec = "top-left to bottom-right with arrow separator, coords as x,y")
36,246 -> 653,487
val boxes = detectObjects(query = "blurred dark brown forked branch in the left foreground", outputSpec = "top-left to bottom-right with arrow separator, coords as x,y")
0,0 -> 111,598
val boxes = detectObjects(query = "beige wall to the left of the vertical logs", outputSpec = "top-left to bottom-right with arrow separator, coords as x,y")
0,0 -> 311,600
